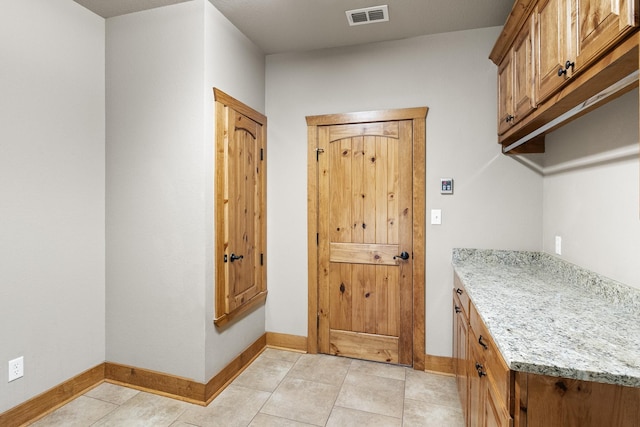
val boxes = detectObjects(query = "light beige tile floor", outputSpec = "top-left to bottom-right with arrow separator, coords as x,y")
33,348 -> 464,427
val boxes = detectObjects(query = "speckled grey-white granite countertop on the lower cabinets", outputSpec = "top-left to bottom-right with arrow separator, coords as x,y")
453,249 -> 640,387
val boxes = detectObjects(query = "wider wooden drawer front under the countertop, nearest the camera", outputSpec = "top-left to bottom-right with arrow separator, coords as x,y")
469,304 -> 511,407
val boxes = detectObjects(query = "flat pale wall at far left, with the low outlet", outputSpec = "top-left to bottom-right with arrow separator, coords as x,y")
0,0 -> 105,413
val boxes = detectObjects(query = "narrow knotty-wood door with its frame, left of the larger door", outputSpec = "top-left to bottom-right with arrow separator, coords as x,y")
215,90 -> 267,326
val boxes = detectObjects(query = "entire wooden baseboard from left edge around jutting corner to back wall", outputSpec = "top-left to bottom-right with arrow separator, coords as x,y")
0,333 -> 267,427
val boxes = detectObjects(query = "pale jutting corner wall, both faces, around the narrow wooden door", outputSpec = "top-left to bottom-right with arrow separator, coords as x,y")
106,0 -> 265,382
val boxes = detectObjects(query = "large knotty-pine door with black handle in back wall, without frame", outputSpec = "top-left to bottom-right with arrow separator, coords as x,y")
318,120 -> 413,365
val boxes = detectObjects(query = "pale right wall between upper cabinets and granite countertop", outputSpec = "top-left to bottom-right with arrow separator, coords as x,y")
543,90 -> 640,289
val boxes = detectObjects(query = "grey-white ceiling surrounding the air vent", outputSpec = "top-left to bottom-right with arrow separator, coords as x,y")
74,0 -> 513,54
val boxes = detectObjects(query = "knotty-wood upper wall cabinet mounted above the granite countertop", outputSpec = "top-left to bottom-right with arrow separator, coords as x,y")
490,0 -> 638,153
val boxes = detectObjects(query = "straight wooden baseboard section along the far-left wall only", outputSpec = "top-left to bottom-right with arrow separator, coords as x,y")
0,363 -> 105,427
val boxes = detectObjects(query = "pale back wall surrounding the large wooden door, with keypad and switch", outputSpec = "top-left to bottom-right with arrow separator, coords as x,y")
266,28 -> 542,356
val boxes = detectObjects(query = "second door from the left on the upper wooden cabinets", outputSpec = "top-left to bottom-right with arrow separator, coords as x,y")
513,15 -> 536,121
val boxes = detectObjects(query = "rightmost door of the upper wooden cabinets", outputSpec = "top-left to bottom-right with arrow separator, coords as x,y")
572,0 -> 637,70
